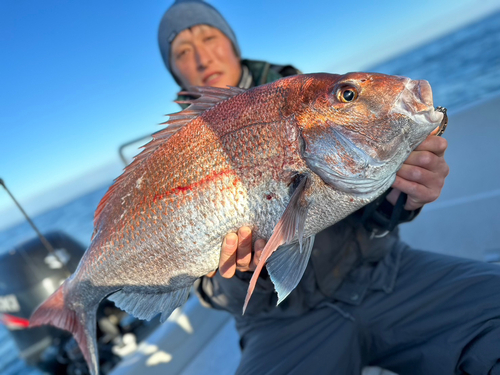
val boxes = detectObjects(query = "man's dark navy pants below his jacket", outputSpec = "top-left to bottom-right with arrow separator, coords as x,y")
237,250 -> 500,375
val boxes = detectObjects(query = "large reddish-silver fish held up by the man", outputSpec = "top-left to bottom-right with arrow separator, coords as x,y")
30,73 -> 444,374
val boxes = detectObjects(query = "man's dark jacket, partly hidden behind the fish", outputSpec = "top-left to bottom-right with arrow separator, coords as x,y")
188,60 -> 417,326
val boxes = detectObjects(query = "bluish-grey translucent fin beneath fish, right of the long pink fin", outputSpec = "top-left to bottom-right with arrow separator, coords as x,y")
266,236 -> 314,305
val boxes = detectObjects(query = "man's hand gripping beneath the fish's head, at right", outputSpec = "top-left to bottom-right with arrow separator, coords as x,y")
387,135 -> 450,211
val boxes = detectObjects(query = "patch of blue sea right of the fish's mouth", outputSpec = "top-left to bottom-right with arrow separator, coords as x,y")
370,12 -> 500,112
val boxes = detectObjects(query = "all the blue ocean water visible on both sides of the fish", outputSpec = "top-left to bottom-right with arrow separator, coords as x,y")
0,12 -> 500,375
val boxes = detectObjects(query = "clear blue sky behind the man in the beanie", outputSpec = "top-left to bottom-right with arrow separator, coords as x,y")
0,0 -> 500,227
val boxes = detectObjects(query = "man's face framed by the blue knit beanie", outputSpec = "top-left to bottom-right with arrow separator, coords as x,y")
170,25 -> 241,88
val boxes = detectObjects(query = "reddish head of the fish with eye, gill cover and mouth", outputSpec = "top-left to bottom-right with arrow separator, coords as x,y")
289,73 -> 443,194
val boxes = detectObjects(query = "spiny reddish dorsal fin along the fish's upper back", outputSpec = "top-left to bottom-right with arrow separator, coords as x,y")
92,87 -> 246,229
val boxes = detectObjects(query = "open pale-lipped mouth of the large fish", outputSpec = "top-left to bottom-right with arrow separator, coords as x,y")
392,78 -> 446,129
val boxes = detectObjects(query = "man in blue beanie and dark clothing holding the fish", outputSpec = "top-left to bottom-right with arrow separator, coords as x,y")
159,0 -> 500,374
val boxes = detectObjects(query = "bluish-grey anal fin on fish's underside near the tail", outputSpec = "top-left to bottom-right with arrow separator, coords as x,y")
108,287 -> 191,323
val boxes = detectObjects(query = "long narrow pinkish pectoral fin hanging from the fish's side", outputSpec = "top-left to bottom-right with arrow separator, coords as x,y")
243,176 -> 308,314
